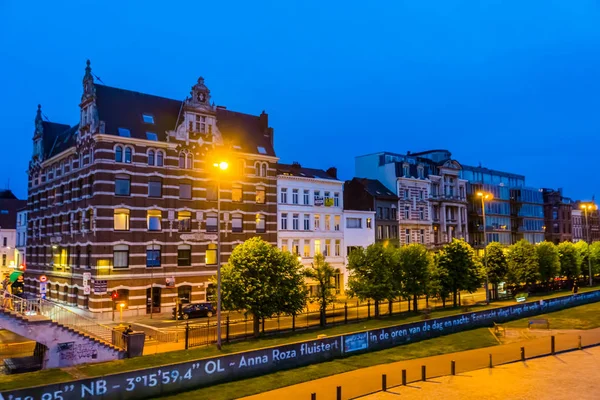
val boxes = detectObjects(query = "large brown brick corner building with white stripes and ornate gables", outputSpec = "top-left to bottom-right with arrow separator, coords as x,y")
26,61 -> 277,315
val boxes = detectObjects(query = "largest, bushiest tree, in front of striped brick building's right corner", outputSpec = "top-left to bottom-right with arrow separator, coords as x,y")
221,237 -> 307,336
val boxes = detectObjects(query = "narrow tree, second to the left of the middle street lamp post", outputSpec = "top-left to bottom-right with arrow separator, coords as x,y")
397,244 -> 431,311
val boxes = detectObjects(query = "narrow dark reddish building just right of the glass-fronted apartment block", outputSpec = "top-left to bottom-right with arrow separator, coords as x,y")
542,189 -> 573,244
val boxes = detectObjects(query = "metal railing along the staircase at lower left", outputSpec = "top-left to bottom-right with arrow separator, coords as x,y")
1,294 -> 123,348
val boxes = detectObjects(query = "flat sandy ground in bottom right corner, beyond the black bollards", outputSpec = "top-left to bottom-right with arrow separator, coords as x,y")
362,347 -> 600,400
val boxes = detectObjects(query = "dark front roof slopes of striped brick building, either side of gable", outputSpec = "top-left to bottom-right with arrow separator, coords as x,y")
95,84 -> 275,156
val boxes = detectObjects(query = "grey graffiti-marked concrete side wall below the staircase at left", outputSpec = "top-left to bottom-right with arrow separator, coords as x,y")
0,312 -> 124,369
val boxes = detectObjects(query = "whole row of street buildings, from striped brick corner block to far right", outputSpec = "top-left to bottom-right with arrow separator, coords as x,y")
18,61 -> 600,316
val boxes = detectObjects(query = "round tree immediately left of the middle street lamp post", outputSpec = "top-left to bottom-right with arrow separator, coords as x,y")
436,239 -> 481,307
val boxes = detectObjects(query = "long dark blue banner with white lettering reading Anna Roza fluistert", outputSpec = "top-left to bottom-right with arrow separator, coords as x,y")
0,291 -> 600,400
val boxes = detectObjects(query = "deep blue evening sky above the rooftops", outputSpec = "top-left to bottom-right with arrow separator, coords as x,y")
0,0 -> 600,199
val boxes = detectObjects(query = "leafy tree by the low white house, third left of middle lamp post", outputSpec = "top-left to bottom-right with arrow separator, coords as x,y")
348,243 -> 399,317
